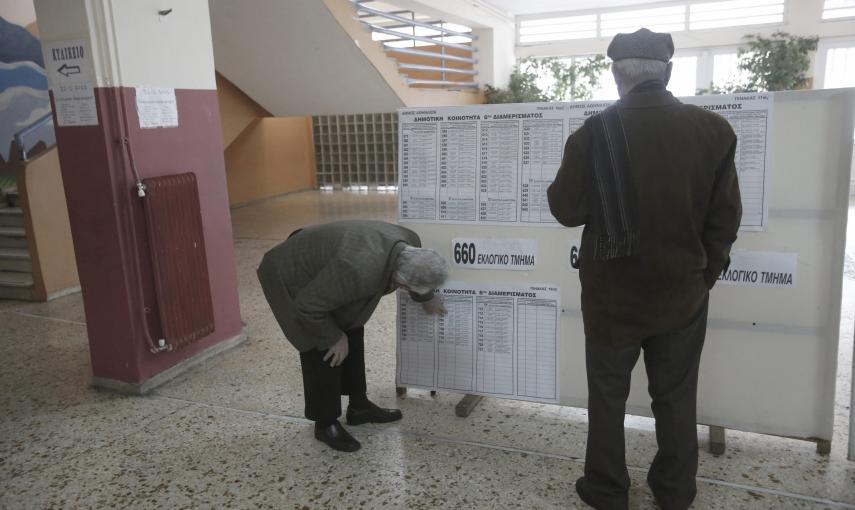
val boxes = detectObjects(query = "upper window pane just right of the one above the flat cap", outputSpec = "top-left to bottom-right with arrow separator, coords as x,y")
689,0 -> 784,30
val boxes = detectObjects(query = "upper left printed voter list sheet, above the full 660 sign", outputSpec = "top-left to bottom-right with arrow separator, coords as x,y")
398,103 -> 570,227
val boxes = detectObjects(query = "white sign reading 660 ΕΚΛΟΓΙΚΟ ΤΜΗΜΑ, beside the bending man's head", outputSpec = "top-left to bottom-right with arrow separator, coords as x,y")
451,237 -> 537,271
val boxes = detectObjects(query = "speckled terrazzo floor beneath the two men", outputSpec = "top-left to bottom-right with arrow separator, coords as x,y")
0,192 -> 855,509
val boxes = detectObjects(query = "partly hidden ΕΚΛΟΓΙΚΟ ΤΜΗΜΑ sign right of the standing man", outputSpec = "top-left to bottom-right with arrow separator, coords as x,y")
718,250 -> 798,288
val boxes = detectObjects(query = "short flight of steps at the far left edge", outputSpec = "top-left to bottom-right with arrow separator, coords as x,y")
0,207 -> 34,301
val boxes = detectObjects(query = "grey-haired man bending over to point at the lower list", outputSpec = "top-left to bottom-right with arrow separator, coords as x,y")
258,221 -> 448,452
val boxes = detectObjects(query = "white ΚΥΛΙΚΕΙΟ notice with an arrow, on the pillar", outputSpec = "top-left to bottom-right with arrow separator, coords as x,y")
45,39 -> 98,127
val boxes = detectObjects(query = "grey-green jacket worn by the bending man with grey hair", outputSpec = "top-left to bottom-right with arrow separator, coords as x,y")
258,220 -> 432,352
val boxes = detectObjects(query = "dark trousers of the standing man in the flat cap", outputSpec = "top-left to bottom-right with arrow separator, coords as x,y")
585,298 -> 709,510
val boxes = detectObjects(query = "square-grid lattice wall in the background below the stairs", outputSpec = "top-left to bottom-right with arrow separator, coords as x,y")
312,113 -> 398,189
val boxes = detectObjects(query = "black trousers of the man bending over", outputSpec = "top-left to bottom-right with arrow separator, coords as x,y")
300,328 -> 367,423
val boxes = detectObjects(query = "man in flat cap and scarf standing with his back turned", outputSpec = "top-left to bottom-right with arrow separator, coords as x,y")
548,28 -> 742,510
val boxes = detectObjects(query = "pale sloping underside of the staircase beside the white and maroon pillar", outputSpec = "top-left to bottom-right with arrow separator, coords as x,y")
210,0 -> 403,116
